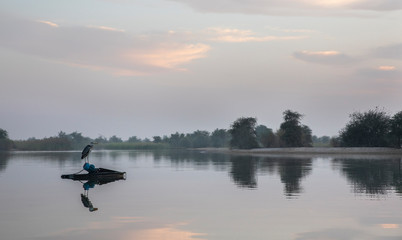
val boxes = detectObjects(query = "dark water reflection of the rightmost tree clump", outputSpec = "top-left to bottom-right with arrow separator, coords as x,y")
333,158 -> 402,196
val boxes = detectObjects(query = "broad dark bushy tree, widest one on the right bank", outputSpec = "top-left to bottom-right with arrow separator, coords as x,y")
339,108 -> 390,147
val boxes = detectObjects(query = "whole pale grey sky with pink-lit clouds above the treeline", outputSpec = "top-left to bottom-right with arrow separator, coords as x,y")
0,0 -> 402,140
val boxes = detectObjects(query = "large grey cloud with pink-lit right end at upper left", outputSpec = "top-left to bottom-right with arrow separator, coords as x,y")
0,15 -> 210,76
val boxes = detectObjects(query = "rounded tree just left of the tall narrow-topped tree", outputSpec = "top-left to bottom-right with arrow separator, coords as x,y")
229,117 -> 258,149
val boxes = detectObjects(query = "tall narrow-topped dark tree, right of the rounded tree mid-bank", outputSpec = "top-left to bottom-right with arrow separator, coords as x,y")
279,110 -> 304,147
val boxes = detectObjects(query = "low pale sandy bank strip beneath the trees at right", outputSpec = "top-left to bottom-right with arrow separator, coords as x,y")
191,147 -> 402,157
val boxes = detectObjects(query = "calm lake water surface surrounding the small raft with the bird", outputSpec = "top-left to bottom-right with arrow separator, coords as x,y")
0,151 -> 402,240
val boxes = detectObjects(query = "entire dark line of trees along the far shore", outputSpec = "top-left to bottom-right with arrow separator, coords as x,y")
0,108 -> 402,151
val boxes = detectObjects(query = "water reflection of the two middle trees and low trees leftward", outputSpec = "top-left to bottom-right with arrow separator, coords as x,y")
148,151 -> 313,197
